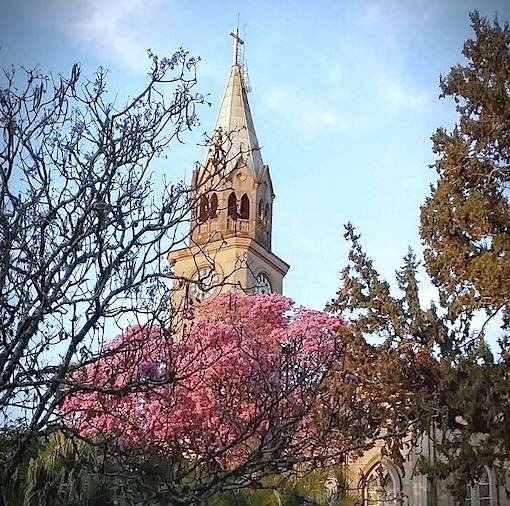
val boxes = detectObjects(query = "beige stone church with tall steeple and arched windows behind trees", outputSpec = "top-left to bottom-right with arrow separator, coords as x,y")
169,30 -> 510,506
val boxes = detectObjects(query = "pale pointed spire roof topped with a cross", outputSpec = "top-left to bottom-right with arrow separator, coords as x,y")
205,29 -> 264,178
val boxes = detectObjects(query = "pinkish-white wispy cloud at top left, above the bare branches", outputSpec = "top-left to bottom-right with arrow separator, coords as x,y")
48,0 -> 161,71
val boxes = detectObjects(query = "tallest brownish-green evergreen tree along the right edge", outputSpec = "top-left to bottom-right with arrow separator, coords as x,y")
421,12 -> 510,490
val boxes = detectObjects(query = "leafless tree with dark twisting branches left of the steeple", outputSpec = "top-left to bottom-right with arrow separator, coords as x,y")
0,49 -> 217,454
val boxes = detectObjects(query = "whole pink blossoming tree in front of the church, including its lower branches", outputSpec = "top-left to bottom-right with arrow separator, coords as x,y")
60,294 -> 390,503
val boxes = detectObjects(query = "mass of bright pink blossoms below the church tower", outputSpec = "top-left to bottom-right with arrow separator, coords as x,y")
61,294 -> 346,462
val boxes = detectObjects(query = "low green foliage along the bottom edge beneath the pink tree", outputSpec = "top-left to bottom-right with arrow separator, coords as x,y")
0,430 -> 351,506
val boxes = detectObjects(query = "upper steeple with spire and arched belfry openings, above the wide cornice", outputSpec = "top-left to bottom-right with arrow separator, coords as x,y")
191,29 -> 274,250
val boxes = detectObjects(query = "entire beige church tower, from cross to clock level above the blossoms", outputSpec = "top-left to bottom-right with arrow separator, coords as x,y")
169,29 -> 289,308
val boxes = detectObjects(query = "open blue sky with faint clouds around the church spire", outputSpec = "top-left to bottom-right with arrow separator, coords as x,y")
0,0 -> 510,308
